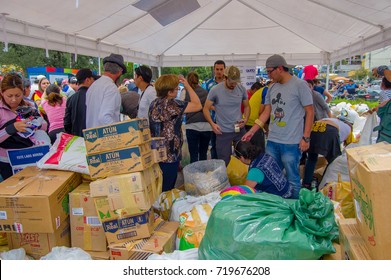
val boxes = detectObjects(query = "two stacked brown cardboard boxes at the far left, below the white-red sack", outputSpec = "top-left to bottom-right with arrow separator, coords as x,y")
0,167 -> 81,259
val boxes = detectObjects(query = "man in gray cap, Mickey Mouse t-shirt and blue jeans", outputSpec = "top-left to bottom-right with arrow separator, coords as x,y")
242,54 -> 314,198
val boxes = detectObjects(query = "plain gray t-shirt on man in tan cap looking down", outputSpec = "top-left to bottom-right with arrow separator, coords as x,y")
207,82 -> 248,133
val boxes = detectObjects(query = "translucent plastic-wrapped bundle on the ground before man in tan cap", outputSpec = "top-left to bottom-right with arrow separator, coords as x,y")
183,159 -> 230,196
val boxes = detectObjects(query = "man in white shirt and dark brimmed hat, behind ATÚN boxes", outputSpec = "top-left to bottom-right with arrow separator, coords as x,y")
86,53 -> 126,128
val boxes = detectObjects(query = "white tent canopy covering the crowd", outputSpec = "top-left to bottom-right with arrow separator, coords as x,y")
0,0 -> 391,66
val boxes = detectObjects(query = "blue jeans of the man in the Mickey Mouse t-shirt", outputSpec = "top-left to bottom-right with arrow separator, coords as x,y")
266,141 -> 301,198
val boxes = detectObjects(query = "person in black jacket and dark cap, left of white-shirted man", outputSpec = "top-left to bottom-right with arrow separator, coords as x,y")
64,68 -> 99,137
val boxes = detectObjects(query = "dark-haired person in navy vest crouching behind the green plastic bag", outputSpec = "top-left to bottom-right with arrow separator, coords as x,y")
235,141 -> 292,198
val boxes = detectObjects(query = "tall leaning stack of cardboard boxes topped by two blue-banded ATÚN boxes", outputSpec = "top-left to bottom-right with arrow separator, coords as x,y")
82,119 -> 178,259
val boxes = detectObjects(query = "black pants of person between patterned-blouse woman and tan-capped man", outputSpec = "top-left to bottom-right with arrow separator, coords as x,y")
186,129 -> 213,163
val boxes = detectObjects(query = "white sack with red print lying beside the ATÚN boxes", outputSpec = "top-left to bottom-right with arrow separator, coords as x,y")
37,133 -> 90,175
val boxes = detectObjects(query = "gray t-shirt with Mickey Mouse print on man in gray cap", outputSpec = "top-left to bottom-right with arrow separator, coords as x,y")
265,76 -> 313,144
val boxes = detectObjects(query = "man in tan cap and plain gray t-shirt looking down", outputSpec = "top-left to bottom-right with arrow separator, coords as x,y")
203,66 -> 250,165
